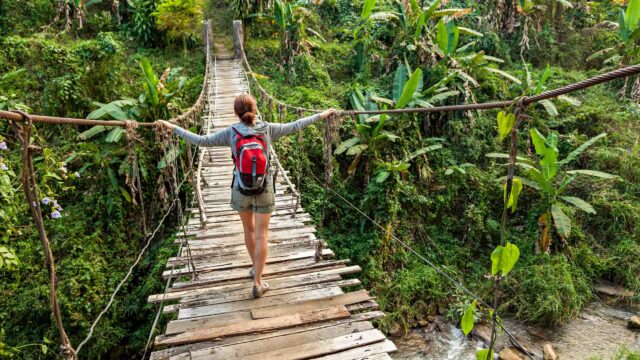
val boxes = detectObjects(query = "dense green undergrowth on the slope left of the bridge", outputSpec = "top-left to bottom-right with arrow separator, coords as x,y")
0,1 -> 205,359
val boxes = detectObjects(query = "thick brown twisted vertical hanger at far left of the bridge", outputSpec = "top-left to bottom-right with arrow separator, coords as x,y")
12,111 -> 78,359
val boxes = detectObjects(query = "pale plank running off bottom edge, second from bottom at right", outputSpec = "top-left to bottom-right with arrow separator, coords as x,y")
243,329 -> 385,360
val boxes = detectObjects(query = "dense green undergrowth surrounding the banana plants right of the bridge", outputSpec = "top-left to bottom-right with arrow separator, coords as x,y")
236,0 -> 640,329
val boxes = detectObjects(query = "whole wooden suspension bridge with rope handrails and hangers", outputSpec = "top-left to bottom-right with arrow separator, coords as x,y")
0,16 -> 640,360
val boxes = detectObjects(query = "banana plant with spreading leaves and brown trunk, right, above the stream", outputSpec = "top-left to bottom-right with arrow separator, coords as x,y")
486,128 -> 617,252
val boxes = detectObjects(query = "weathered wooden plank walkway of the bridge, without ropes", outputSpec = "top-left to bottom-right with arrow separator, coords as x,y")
143,32 -> 396,359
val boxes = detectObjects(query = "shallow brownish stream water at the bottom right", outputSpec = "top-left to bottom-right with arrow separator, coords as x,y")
392,302 -> 640,360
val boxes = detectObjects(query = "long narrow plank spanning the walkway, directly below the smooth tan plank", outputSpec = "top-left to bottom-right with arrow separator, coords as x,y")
151,311 -> 384,360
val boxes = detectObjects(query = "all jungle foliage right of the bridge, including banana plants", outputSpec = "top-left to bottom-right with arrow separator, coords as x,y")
232,0 -> 640,344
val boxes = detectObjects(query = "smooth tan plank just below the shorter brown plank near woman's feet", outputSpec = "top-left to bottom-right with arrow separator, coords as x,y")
155,305 -> 351,346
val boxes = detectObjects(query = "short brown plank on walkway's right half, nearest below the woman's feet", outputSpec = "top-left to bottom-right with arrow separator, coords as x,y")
251,290 -> 373,319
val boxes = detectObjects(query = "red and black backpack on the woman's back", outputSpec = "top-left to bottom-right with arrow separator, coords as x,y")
231,127 -> 269,195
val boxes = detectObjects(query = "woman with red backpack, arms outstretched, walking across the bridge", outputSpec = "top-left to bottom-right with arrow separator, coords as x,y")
158,94 -> 335,298
